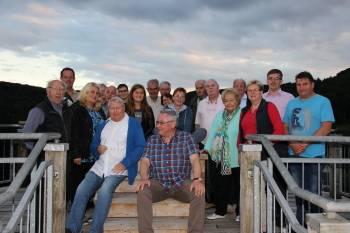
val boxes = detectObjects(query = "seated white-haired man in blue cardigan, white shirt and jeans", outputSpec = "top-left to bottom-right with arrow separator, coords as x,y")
66,97 -> 145,233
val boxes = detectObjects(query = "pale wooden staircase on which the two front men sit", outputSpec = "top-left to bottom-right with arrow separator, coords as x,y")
104,177 -> 189,233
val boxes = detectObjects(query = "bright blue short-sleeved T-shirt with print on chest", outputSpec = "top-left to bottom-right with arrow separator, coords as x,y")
283,94 -> 334,158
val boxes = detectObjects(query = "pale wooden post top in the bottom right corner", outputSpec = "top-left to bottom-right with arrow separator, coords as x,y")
306,213 -> 350,233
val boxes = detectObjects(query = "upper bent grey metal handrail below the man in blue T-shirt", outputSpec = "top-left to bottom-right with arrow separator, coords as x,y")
247,134 -> 350,212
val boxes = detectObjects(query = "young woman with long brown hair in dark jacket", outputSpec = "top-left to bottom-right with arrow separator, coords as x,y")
126,84 -> 154,139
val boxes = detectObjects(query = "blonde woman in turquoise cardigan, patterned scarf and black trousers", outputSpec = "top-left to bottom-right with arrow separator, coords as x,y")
204,88 -> 241,220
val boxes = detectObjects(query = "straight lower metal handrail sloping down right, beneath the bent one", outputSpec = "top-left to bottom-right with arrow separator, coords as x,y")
254,161 -> 307,233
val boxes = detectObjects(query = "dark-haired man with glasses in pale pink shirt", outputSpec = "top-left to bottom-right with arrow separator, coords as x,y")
263,69 -> 294,119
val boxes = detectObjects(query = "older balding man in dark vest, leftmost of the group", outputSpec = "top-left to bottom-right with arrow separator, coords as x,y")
23,80 -> 67,147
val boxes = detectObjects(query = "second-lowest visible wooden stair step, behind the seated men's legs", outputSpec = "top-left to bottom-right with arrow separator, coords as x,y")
108,193 -> 190,218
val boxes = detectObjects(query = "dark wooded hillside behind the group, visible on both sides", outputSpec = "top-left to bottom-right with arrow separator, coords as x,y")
0,68 -> 350,126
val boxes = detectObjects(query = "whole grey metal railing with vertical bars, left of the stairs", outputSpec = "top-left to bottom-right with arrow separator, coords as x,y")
0,133 -> 60,232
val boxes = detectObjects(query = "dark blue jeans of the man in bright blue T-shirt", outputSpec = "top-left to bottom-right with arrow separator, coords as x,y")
289,163 -> 322,224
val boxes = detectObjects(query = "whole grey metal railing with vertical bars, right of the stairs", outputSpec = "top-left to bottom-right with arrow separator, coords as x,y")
248,135 -> 350,232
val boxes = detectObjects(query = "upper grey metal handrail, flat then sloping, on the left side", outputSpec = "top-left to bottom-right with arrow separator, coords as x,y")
0,133 -> 61,205
